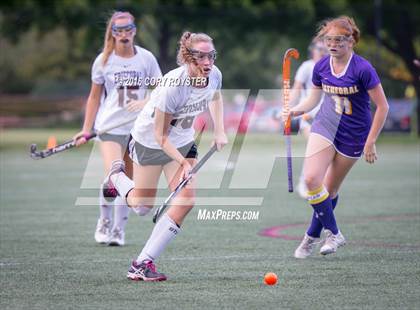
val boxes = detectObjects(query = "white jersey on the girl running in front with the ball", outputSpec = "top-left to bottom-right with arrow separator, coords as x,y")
131,66 -> 222,149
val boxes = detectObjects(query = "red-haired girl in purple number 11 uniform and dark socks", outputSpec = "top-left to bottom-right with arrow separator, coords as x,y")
283,16 -> 388,258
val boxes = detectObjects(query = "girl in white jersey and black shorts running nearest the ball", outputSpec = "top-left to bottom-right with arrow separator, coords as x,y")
101,32 -> 227,281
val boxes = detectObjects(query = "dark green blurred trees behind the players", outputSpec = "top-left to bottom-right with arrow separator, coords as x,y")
0,0 -> 420,135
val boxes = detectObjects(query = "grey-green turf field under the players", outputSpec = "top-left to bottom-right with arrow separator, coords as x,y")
0,130 -> 420,309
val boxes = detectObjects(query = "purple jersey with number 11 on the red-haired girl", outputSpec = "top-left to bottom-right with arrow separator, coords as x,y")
312,54 -> 380,157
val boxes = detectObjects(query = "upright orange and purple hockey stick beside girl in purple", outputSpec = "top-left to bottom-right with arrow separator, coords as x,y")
283,48 -> 299,193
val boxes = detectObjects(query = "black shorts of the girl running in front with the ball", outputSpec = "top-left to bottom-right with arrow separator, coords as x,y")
128,137 -> 198,166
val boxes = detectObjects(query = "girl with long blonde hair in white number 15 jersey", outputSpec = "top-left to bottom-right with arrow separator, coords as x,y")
74,12 -> 162,245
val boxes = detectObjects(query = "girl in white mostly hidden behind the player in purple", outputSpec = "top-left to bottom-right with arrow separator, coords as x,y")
291,38 -> 327,199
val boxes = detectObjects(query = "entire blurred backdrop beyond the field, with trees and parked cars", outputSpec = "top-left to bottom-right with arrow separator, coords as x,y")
0,0 -> 420,136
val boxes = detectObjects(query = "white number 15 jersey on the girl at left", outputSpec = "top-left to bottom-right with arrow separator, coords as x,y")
92,46 -> 162,135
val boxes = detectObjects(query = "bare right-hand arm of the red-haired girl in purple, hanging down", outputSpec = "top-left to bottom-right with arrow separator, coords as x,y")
364,84 -> 389,163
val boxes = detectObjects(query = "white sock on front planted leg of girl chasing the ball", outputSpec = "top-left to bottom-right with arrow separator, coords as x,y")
137,213 -> 181,263
